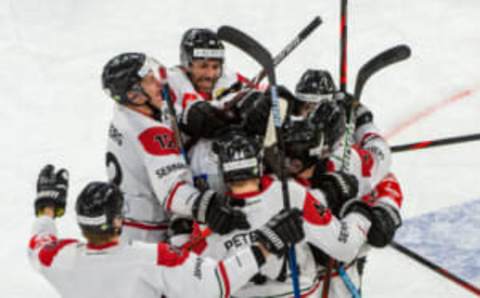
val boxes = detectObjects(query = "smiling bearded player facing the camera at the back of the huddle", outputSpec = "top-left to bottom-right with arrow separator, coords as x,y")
169,28 -> 248,139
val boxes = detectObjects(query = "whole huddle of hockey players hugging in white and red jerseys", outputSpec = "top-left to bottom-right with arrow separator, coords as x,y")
29,28 -> 403,298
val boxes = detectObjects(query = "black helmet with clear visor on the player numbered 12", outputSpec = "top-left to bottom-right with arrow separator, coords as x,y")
102,53 -> 166,104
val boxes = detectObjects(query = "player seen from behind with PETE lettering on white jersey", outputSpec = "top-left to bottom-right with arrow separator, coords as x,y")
189,131 -> 376,297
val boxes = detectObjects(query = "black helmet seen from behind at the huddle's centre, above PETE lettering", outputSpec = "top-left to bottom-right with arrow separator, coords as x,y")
212,129 -> 263,183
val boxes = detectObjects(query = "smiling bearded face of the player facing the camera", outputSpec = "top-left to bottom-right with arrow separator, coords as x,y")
190,59 -> 222,93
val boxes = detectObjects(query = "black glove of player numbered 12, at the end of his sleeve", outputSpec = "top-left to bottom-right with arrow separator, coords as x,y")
192,190 -> 250,235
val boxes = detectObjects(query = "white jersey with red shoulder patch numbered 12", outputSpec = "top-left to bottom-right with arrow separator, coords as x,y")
106,105 -> 198,242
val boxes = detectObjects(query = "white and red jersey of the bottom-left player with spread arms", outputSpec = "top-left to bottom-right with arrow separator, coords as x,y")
29,216 -> 258,298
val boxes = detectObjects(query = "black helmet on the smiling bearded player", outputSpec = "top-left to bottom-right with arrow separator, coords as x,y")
180,28 -> 225,68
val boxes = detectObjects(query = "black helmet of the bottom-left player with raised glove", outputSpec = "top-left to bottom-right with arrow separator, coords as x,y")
75,182 -> 123,234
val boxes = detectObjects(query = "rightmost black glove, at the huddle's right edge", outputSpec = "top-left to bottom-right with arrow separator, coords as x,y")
367,204 -> 402,247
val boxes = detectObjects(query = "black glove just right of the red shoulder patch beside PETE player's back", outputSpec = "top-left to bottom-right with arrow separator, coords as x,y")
310,171 -> 358,215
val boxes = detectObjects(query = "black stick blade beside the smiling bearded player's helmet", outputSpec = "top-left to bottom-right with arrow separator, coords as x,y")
217,26 -> 275,82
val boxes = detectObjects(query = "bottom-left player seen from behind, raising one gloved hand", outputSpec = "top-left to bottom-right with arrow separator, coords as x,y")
29,165 -> 304,298
